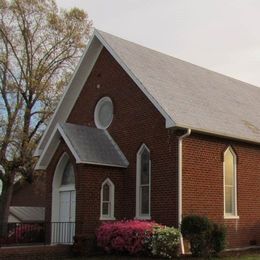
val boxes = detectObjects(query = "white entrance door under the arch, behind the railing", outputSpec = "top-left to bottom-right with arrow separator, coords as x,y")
58,190 -> 76,244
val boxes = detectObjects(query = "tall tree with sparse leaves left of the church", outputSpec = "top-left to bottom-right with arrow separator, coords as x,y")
0,0 -> 92,234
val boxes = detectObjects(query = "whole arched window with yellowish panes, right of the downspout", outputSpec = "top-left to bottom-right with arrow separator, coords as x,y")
224,147 -> 237,218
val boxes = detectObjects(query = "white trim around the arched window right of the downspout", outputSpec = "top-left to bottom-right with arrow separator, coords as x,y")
223,146 -> 239,219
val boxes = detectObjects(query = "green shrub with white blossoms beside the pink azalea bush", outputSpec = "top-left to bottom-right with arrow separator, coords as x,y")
148,226 -> 180,258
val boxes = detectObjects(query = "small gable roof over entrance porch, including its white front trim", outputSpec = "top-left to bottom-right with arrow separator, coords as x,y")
37,123 -> 129,169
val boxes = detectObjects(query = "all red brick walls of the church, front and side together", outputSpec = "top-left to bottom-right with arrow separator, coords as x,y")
46,46 -> 260,250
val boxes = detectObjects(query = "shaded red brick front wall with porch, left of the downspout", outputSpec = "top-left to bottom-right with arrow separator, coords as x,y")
47,49 -> 177,238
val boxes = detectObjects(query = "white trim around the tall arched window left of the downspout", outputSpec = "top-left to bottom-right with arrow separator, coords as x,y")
135,144 -> 151,220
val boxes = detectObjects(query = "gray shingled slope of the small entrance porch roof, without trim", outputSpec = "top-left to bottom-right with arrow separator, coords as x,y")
60,123 -> 128,167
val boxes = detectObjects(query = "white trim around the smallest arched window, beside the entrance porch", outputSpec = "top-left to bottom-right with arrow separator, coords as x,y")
100,178 -> 115,220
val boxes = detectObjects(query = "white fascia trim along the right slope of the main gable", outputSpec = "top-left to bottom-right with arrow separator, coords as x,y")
94,30 -> 176,128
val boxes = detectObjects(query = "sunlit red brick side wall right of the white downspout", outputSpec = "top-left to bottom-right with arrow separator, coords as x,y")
183,134 -> 260,248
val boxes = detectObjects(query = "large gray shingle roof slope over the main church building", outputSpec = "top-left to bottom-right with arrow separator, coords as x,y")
98,31 -> 260,143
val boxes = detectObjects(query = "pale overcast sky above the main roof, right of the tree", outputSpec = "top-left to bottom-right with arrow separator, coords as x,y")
57,0 -> 260,86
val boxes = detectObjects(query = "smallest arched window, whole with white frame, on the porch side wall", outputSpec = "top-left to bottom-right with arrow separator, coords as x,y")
100,179 -> 115,220
